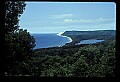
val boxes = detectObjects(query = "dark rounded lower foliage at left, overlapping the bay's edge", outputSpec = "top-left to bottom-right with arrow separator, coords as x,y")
5,29 -> 35,75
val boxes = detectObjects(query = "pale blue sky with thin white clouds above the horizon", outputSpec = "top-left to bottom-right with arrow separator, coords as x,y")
19,1 -> 116,33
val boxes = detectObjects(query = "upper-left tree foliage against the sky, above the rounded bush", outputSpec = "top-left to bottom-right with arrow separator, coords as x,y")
5,1 -> 26,34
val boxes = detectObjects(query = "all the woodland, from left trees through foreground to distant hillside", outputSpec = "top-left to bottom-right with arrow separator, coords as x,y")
4,1 -> 116,77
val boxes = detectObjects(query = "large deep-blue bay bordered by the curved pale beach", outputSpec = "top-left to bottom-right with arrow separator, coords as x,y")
31,33 -> 70,49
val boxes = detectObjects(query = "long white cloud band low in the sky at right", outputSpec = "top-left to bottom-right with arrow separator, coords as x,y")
64,17 -> 113,23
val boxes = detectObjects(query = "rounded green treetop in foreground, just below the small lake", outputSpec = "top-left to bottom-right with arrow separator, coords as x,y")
75,45 -> 101,65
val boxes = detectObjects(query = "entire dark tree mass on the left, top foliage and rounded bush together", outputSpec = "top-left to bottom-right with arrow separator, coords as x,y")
5,1 -> 35,75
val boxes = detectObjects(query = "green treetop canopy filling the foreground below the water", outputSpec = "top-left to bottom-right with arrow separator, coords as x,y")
33,40 -> 115,77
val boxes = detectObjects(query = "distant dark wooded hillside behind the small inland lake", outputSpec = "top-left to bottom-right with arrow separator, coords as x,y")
62,30 -> 116,45
